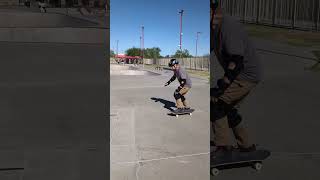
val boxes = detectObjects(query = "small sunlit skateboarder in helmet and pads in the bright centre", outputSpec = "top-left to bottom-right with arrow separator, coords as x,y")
165,59 -> 192,113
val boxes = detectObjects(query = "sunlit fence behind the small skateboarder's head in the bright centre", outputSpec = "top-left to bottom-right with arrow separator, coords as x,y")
144,57 -> 210,71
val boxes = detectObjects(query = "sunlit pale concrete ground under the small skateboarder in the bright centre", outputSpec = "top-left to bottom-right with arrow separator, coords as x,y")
110,65 -> 209,180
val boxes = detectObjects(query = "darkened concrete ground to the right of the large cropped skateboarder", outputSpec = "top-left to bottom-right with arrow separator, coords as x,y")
211,40 -> 320,180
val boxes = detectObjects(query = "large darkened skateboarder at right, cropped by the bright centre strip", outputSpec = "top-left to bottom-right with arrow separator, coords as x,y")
210,0 -> 261,154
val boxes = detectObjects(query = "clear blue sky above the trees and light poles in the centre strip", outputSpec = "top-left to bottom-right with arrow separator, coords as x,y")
110,0 -> 210,56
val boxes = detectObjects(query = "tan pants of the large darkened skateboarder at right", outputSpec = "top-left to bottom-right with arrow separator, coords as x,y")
211,80 -> 257,148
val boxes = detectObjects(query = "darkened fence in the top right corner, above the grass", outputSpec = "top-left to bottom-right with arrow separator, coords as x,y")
222,0 -> 320,31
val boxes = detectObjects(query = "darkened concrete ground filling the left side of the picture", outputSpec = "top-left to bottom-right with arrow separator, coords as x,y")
0,9 -> 109,180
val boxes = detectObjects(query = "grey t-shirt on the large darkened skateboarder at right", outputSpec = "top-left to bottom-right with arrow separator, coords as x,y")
218,15 -> 262,82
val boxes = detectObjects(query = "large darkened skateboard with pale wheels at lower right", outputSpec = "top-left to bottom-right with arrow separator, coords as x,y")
210,149 -> 271,176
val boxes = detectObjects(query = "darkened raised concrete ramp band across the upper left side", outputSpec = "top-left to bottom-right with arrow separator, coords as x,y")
0,9 -> 109,44
